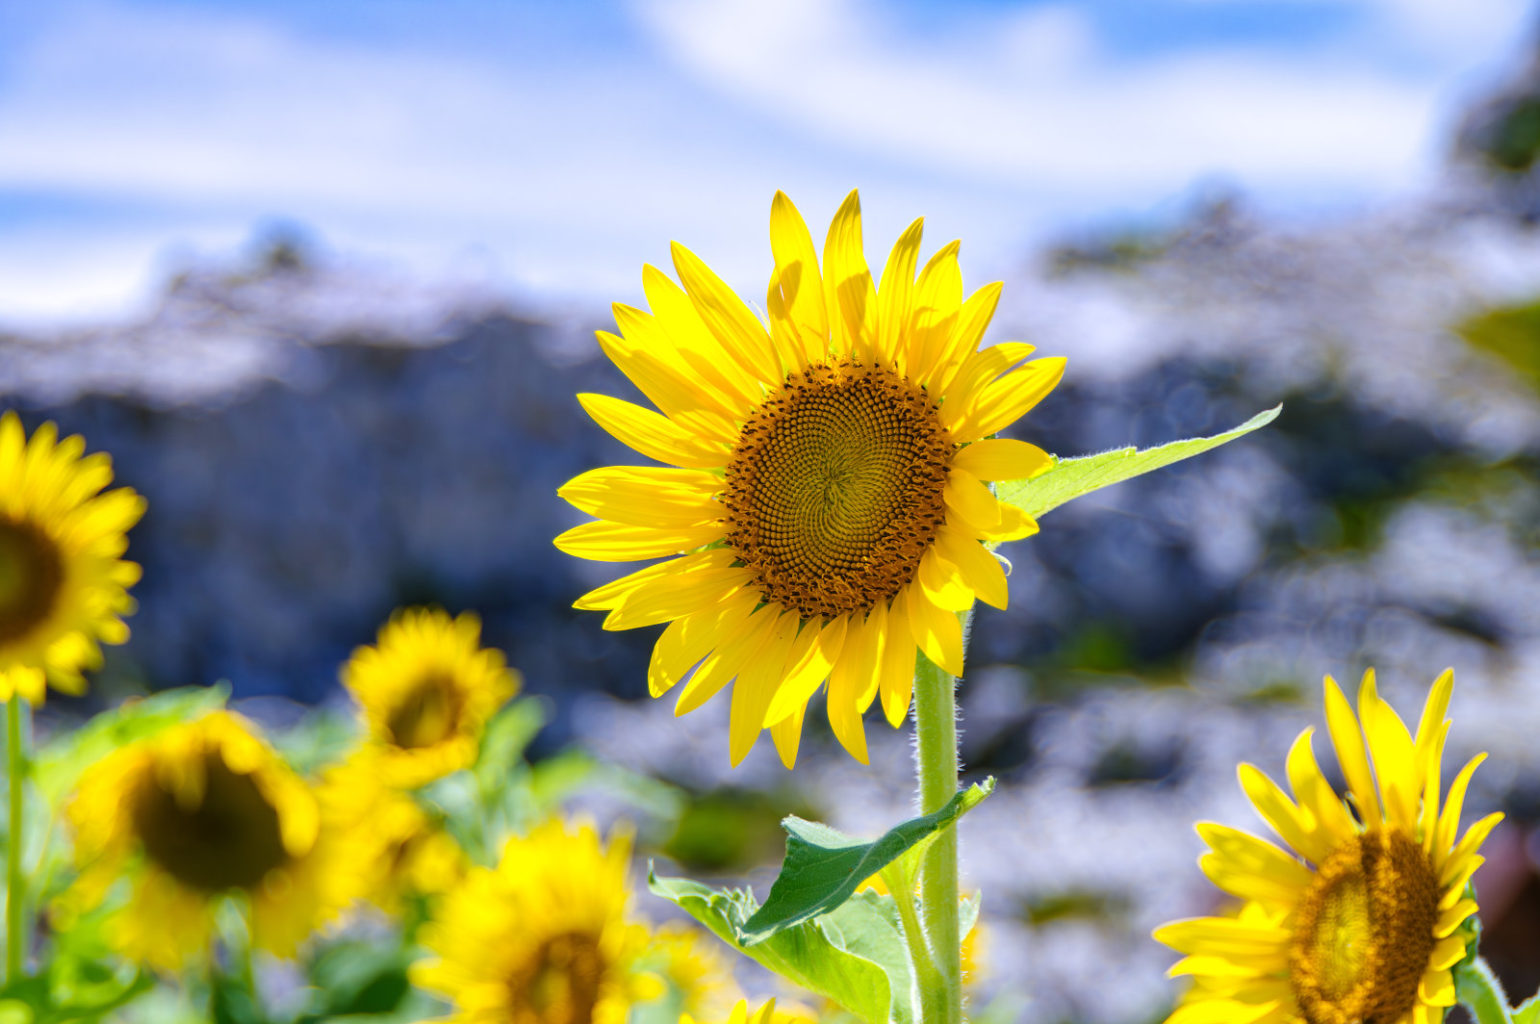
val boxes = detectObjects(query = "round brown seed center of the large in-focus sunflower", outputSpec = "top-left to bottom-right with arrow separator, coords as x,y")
725,360 -> 956,619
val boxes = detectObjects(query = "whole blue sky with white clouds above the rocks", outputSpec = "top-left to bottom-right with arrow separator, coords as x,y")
0,0 -> 1534,326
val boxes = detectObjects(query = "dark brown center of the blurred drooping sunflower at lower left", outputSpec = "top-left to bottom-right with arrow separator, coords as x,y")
132,751 -> 288,892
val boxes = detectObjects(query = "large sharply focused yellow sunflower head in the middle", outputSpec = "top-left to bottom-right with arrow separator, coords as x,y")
556,192 -> 1064,765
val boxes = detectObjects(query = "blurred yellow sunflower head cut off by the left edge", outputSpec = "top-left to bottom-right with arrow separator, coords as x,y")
0,413 -> 145,704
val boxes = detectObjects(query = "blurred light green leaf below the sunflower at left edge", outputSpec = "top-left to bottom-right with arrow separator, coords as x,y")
32,685 -> 229,805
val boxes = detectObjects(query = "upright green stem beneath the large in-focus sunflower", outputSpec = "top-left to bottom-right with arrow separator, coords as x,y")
915,606 -> 970,1024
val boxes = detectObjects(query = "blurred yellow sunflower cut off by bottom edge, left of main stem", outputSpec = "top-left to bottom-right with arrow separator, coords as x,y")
411,821 -> 664,1024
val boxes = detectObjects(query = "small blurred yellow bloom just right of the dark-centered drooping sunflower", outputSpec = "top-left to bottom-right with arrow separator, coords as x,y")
317,748 -> 470,915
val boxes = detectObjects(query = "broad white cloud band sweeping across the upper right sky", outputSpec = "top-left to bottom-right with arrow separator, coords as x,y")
638,0 -> 1514,199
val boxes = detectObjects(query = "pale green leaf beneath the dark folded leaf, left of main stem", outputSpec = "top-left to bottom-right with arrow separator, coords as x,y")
647,870 -> 915,1024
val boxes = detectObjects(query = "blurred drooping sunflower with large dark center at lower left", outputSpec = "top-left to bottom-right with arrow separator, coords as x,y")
55,711 -> 356,972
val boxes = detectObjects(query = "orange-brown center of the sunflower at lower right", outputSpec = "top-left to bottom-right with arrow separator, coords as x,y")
1289,828 -> 1438,1024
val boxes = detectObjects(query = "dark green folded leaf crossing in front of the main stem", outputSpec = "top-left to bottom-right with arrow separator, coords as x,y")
739,779 -> 995,945
